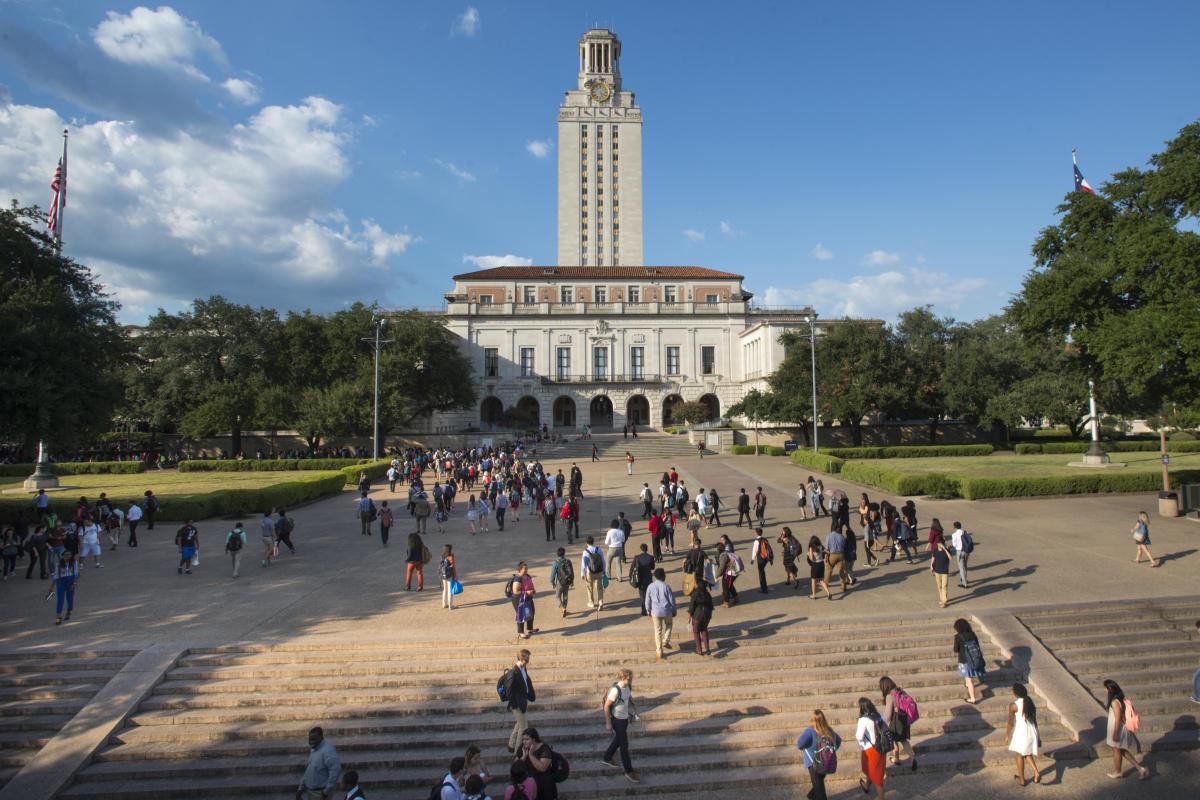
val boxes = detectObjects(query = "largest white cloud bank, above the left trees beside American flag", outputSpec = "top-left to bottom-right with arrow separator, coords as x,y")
0,97 -> 420,321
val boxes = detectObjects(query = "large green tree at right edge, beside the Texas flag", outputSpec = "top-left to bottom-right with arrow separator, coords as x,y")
1010,122 -> 1200,413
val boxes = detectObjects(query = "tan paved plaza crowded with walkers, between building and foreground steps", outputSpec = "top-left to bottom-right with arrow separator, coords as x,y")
0,456 -> 1200,798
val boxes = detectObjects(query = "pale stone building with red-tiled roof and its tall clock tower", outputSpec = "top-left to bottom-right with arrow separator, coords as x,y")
433,29 -> 816,431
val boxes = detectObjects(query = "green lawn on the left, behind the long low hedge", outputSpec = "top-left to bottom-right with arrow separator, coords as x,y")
0,470 -> 340,503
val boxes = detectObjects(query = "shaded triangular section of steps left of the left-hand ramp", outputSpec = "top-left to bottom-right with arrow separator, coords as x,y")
0,650 -> 136,787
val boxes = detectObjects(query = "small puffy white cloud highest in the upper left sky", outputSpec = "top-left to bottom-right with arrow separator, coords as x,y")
91,6 -> 226,80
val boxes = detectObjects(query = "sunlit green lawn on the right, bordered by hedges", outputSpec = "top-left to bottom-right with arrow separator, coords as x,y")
884,452 -> 1200,477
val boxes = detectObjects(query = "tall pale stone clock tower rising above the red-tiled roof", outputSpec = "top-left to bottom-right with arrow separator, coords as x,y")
558,28 -> 643,266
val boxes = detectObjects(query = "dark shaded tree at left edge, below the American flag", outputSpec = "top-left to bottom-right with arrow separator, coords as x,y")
0,203 -> 126,457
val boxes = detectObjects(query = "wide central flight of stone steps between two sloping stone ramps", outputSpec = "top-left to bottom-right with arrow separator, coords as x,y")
64,612 -> 1088,800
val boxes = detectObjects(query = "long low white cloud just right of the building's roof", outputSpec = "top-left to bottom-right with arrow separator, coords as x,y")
763,267 -> 988,320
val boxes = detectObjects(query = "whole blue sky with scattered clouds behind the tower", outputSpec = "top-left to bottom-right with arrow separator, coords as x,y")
0,0 -> 1200,321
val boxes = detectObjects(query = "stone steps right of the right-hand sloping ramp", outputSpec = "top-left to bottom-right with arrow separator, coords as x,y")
1019,597 -> 1200,750
